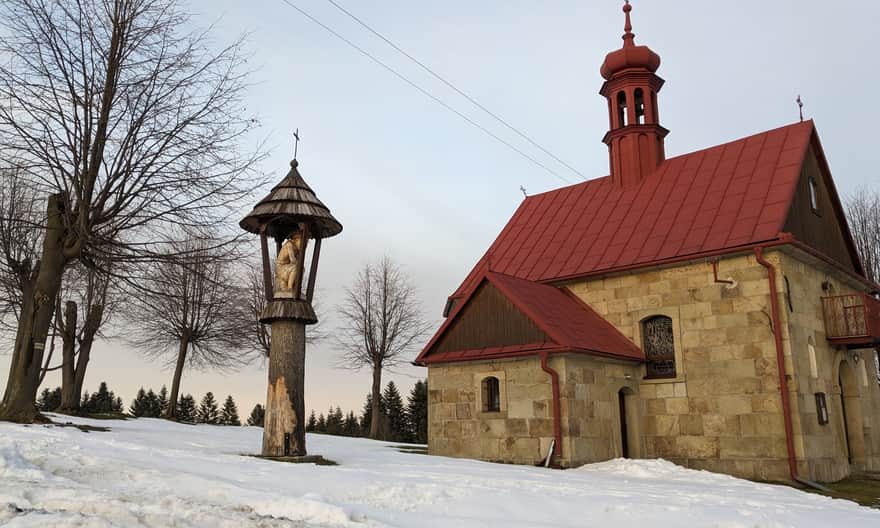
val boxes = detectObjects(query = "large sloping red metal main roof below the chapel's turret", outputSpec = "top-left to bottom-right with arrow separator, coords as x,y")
452,120 -> 814,298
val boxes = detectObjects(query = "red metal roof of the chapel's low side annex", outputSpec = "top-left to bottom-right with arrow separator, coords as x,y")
416,272 -> 645,364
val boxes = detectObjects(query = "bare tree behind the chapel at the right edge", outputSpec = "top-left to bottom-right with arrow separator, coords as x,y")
845,188 -> 880,282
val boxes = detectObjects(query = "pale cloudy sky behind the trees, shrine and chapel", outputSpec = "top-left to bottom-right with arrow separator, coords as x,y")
0,0 -> 880,417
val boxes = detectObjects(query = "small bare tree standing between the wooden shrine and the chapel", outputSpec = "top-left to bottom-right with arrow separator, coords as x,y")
336,257 -> 428,439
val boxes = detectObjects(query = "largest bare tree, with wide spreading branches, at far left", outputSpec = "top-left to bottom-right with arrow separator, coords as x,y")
0,0 -> 257,422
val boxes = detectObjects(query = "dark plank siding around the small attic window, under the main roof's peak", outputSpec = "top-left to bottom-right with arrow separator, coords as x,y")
785,148 -> 856,272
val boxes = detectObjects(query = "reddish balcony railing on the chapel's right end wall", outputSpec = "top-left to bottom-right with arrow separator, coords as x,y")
822,293 -> 880,344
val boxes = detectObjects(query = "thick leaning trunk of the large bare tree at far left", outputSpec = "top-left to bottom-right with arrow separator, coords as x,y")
0,195 -> 67,423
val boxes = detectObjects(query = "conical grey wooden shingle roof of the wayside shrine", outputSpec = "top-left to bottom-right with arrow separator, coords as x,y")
239,159 -> 342,238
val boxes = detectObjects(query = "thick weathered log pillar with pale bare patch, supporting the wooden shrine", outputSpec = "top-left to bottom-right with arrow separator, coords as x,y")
263,319 -> 306,456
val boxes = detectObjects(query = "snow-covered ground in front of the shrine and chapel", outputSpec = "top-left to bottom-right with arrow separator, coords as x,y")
0,416 -> 880,528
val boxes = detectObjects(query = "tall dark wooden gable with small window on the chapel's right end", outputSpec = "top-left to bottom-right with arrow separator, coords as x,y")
784,141 -> 862,275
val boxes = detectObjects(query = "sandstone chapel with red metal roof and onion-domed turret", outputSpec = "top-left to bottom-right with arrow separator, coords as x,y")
416,2 -> 880,481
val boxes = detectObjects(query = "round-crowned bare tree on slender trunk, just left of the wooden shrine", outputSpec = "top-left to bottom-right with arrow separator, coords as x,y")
127,240 -> 257,419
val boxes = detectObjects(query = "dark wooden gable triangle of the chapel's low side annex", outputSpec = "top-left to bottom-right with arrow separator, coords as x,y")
431,281 -> 550,353
